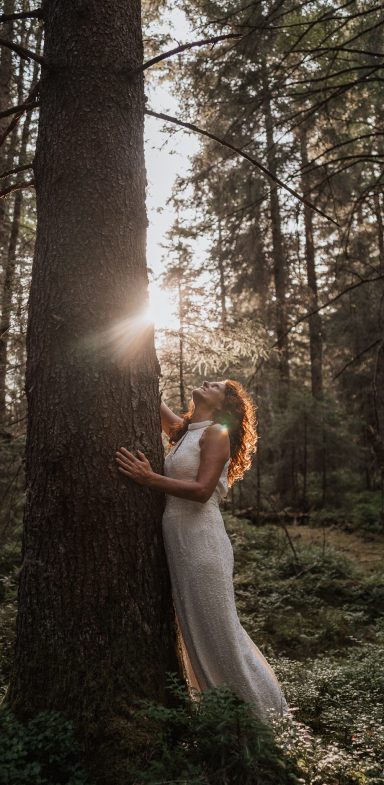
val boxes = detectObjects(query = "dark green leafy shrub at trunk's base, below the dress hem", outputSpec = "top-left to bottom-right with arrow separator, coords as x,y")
134,675 -> 299,785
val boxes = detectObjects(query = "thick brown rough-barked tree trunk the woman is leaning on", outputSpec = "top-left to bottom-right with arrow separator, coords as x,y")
7,0 -> 176,785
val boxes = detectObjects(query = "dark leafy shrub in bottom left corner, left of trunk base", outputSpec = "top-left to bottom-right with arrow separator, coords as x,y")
0,706 -> 89,785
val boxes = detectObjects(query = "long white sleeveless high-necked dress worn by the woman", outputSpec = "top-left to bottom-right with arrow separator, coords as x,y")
162,420 -> 289,722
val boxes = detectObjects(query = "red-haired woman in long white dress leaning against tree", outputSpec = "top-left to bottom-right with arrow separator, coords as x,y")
116,380 -> 289,722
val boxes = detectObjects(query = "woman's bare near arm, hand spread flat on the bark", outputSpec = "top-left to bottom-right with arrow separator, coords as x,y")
116,425 -> 229,503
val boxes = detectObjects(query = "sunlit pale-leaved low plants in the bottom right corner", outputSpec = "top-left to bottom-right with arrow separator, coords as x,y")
272,625 -> 384,783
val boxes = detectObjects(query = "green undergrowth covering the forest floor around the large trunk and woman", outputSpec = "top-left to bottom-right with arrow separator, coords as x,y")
0,516 -> 384,785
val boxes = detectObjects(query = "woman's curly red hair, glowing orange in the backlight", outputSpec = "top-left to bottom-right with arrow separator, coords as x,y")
169,379 -> 257,486
